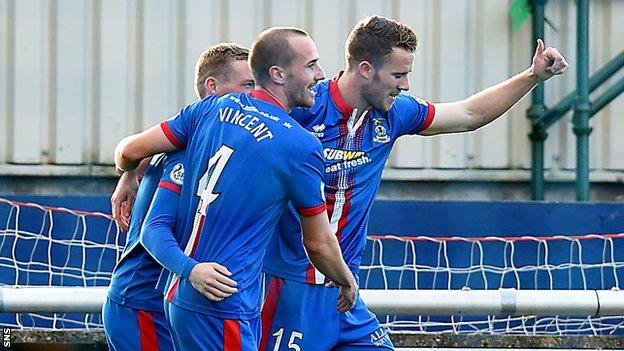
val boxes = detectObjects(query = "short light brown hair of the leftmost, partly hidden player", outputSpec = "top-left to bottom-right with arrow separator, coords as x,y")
195,43 -> 249,99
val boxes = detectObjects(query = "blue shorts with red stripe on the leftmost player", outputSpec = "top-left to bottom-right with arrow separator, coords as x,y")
102,298 -> 173,351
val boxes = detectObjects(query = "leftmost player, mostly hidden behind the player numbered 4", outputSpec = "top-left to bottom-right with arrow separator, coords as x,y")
102,43 -> 254,350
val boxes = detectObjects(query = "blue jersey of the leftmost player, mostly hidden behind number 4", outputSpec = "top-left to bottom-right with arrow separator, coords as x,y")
108,150 -> 185,312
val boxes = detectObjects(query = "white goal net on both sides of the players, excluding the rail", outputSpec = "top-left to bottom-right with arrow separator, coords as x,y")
0,199 -> 624,335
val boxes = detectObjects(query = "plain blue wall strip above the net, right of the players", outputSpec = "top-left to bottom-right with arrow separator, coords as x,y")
369,201 -> 624,237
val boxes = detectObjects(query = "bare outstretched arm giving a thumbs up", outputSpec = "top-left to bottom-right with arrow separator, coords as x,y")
421,39 -> 569,135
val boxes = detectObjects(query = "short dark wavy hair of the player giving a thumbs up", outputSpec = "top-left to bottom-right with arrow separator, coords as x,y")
346,16 -> 418,68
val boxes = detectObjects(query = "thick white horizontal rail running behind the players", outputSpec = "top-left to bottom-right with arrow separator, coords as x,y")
0,287 -> 624,316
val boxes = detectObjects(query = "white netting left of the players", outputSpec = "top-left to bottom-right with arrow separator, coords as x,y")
0,199 -> 125,330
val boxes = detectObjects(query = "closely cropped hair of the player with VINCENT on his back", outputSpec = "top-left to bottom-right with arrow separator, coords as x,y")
249,27 -> 309,85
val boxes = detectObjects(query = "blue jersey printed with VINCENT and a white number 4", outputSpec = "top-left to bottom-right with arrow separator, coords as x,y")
156,90 -> 325,319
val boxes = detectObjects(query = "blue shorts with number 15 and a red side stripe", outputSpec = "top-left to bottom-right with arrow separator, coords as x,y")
260,277 -> 393,351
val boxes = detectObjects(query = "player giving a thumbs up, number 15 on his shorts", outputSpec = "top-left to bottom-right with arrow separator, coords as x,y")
260,16 -> 568,351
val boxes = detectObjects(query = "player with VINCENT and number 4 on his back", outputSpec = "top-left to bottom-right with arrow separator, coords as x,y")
115,28 -> 357,350
